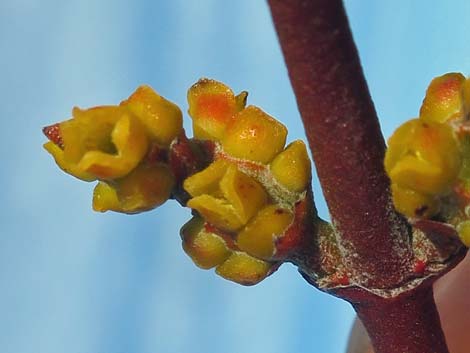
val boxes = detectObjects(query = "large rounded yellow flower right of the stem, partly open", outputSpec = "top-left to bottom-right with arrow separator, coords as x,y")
385,119 -> 461,194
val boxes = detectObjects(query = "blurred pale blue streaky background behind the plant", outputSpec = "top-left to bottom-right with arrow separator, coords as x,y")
0,0 -> 470,353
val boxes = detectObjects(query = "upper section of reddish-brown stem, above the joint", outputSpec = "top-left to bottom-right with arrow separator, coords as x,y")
269,0 -> 412,287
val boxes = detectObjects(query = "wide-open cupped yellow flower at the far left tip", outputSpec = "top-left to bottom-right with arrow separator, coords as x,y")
44,106 -> 148,181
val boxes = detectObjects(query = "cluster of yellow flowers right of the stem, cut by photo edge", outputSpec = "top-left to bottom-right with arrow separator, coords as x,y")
385,73 -> 470,245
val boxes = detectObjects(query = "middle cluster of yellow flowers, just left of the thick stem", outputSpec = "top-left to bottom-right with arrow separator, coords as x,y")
181,79 -> 311,284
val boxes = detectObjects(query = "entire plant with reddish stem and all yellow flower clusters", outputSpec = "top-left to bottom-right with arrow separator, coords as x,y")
44,0 -> 470,353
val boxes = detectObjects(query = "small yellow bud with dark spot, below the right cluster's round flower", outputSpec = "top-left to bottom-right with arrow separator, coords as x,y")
392,184 -> 439,218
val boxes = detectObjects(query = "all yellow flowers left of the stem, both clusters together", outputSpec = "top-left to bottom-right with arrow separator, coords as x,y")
45,79 -> 311,285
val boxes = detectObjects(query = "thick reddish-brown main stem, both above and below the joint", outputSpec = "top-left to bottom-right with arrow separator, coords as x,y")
269,0 -> 463,353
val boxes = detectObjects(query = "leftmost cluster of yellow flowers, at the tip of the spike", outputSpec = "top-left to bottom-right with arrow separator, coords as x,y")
44,86 -> 183,213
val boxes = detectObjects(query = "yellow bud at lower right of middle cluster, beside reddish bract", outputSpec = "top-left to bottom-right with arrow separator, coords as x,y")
237,205 -> 294,260
